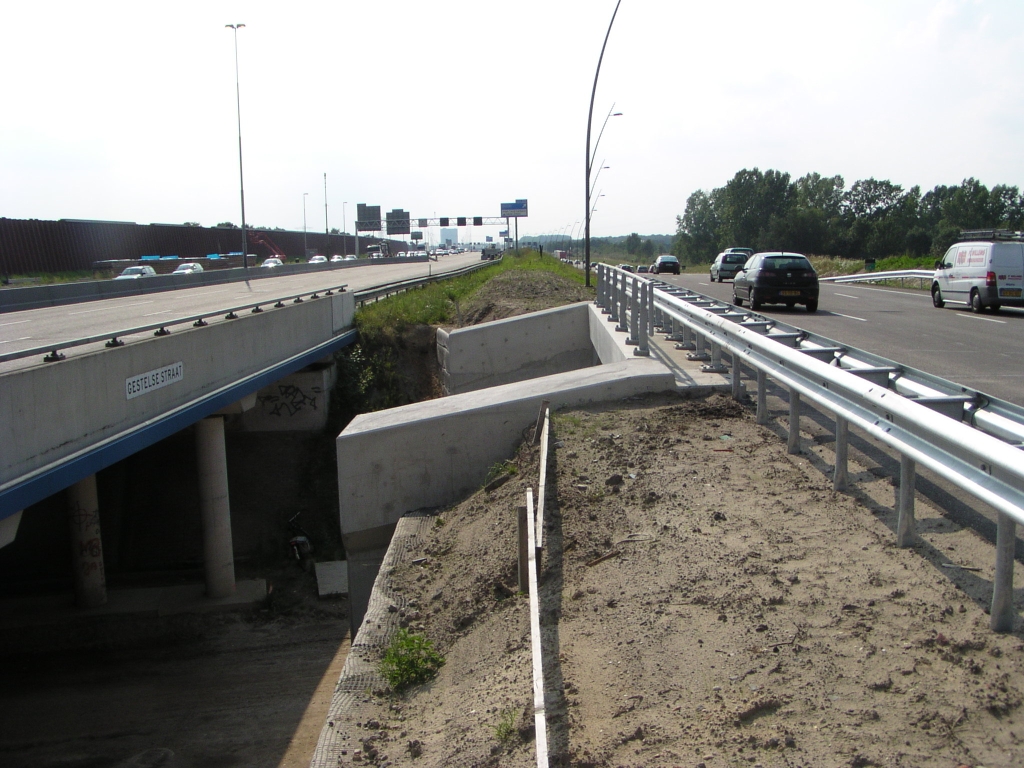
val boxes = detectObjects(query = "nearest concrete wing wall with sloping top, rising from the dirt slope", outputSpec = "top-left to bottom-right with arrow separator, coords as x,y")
337,359 -> 676,554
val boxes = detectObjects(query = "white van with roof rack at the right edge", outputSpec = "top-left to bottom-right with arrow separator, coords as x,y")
932,232 -> 1024,312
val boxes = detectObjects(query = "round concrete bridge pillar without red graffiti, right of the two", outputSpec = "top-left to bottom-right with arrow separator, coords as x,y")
196,416 -> 234,597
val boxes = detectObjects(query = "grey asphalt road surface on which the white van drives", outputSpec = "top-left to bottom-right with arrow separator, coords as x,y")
657,272 -> 1024,406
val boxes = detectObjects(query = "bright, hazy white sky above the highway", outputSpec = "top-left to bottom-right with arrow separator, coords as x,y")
0,0 -> 1024,240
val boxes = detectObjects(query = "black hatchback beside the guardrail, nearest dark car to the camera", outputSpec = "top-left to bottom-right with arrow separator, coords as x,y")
732,252 -> 818,312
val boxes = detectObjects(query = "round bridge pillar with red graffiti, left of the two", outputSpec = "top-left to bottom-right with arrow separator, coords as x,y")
66,475 -> 106,608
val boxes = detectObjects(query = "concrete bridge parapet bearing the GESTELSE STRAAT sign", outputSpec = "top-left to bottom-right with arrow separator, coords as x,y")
0,293 -> 354,488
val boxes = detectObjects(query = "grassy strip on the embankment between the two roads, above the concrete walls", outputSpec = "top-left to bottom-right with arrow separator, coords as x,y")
355,251 -> 585,340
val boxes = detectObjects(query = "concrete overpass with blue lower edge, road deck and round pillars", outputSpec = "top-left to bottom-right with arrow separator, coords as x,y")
0,254 -> 478,606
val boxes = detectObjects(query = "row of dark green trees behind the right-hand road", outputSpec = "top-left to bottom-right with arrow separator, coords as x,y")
673,168 -> 1024,264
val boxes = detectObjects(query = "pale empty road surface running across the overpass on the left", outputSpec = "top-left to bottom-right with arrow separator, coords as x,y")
0,252 -> 480,375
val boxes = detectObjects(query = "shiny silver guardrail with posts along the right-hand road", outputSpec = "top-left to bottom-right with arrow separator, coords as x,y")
597,264 -> 1024,632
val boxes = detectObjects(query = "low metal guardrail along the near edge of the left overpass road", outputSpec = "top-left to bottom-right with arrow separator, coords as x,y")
0,261 -> 494,362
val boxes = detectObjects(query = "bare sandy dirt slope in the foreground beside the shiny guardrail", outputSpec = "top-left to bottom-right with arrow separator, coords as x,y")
342,395 -> 1024,768
